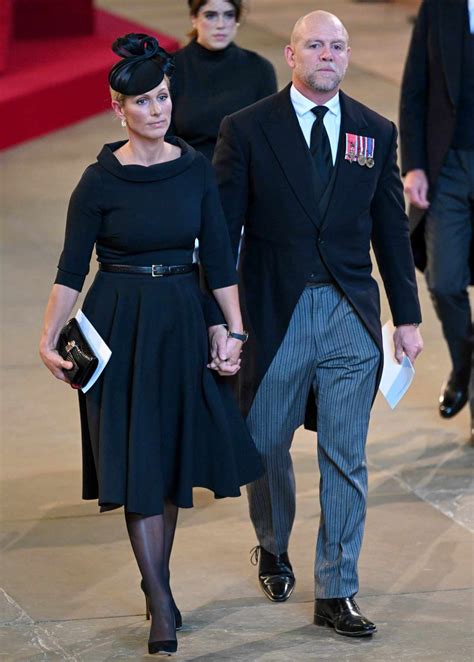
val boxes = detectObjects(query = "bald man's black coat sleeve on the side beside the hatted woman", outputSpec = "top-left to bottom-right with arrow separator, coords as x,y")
212,117 -> 248,262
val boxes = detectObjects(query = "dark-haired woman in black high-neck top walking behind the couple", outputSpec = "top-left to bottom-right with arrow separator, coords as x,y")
170,0 -> 277,160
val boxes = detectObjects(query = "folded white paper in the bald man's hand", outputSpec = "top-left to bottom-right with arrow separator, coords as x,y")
379,320 -> 415,409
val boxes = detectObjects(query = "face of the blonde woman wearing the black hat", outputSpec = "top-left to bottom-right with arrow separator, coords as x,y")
112,79 -> 172,140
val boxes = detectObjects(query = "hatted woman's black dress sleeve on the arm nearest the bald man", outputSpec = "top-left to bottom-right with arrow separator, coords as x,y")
199,157 -> 237,290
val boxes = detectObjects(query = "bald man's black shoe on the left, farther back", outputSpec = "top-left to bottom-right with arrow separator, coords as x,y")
251,546 -> 295,602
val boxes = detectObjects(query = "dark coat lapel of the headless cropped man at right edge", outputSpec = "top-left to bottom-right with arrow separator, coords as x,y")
437,0 -> 467,107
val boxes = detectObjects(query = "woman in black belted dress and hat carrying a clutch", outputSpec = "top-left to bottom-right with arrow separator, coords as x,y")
40,35 -> 262,653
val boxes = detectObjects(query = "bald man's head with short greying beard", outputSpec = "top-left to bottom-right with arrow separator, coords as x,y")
286,16 -> 351,93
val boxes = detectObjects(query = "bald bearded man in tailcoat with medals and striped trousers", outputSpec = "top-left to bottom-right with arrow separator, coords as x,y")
211,11 -> 422,636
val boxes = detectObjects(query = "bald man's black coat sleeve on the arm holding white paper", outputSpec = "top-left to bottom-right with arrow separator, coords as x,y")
371,124 -> 421,326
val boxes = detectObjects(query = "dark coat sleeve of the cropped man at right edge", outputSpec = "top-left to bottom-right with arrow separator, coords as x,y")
399,0 -> 430,175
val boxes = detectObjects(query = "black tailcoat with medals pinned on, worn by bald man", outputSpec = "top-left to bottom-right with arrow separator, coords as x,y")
214,86 -> 421,429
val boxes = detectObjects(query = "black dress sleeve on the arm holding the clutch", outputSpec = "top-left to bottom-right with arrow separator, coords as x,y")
55,166 -> 102,292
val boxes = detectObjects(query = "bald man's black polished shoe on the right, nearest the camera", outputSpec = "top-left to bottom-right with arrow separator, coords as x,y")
314,598 -> 377,637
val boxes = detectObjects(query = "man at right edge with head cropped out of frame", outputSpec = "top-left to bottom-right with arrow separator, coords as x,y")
400,0 -> 474,439
